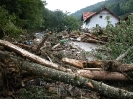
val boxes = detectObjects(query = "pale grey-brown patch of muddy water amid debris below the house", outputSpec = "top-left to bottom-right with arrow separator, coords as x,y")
70,41 -> 99,61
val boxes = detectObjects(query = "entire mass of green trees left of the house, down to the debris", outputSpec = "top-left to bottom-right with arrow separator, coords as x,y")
0,0 -> 79,38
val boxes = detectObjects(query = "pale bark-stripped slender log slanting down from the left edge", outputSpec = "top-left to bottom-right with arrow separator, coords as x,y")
0,40 -> 67,71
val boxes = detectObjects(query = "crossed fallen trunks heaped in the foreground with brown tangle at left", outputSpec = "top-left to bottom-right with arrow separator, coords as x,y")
0,40 -> 133,99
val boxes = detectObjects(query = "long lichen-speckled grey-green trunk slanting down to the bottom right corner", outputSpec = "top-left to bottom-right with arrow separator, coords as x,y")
0,53 -> 133,99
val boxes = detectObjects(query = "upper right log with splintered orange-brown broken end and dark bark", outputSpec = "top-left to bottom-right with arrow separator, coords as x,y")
62,58 -> 133,72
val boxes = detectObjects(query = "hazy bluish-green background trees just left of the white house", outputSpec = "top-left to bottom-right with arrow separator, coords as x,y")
43,9 -> 79,32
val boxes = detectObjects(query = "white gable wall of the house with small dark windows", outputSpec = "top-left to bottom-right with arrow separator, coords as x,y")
84,10 -> 119,28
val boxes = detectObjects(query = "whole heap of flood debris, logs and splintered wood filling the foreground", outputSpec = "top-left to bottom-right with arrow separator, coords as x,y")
0,32 -> 133,99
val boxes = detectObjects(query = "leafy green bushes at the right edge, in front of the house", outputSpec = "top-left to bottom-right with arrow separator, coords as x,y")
97,15 -> 133,63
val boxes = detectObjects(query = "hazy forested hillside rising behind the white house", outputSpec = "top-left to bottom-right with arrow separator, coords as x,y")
71,0 -> 133,21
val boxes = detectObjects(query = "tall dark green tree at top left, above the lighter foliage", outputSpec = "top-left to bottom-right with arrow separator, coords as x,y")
0,0 -> 44,30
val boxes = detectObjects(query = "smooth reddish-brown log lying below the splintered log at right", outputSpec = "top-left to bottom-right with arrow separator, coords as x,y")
77,70 -> 129,80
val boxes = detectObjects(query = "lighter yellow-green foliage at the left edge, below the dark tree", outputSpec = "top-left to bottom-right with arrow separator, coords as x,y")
0,7 -> 24,38
